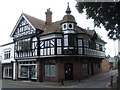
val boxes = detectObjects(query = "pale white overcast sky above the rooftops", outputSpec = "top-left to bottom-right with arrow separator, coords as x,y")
0,0 -> 118,57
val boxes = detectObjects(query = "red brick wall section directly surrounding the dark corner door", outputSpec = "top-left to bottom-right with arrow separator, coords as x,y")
58,57 -> 81,81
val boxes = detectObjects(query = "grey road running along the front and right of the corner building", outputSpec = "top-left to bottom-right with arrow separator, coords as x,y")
0,70 -> 117,88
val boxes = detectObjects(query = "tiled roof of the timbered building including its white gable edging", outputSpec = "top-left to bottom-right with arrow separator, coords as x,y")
10,13 -> 104,42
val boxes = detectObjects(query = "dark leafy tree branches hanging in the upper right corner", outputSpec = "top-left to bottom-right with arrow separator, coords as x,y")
76,2 -> 120,40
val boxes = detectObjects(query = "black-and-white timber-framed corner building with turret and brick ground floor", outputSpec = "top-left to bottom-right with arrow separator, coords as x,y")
11,5 -> 106,82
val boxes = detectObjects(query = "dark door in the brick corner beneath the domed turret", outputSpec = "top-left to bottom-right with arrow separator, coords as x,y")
65,63 -> 73,80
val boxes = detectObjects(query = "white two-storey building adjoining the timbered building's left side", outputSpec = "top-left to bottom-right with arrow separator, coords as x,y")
0,42 -> 16,80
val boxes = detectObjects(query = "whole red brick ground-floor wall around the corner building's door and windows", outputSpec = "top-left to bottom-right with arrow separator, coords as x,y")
38,57 -> 101,82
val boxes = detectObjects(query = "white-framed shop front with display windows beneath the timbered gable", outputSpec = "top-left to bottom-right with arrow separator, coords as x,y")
18,61 -> 37,80
